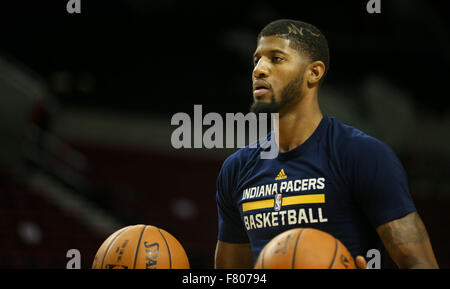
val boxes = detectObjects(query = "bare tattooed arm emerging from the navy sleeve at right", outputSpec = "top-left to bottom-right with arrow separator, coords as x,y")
377,212 -> 438,268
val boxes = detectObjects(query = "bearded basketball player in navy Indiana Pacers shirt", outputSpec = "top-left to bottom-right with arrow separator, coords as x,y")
215,20 -> 438,268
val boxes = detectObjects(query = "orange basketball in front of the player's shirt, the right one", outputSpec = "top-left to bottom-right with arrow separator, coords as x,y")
255,228 -> 356,269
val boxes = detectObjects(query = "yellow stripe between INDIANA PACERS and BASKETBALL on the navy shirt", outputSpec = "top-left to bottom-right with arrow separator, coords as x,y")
242,194 -> 325,212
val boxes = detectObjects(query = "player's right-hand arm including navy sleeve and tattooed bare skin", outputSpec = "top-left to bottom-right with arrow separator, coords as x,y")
343,137 -> 438,268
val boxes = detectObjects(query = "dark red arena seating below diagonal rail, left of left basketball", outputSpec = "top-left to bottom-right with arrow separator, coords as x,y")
0,169 -> 105,269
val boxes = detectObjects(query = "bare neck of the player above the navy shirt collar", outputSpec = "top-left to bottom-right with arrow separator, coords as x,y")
274,95 -> 323,152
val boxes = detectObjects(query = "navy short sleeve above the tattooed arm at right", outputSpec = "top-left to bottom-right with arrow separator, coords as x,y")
342,136 -> 416,227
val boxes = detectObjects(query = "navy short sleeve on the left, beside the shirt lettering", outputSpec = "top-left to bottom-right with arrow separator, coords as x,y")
216,155 -> 249,243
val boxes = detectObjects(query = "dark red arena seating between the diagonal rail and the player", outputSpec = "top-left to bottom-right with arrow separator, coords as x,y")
76,146 -> 223,268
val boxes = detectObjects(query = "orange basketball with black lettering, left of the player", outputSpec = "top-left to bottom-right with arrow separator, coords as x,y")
92,225 -> 189,269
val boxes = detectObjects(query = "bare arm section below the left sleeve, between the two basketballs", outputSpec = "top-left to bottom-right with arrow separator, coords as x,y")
214,241 -> 253,269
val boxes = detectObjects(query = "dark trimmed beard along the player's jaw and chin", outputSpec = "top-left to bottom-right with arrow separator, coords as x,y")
250,74 -> 303,117
